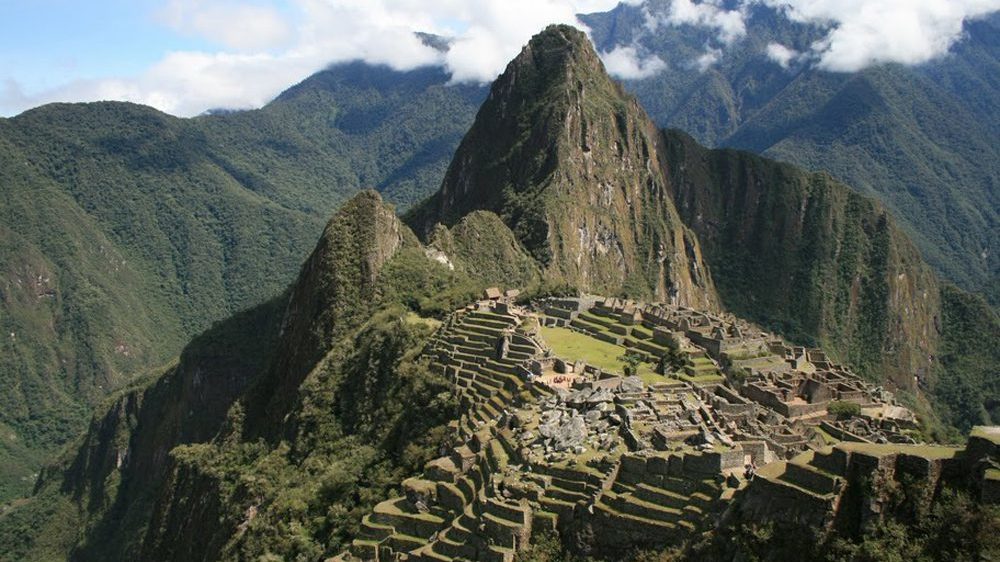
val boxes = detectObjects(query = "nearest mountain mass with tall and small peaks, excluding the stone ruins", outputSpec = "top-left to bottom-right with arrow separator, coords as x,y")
0,26 -> 1000,561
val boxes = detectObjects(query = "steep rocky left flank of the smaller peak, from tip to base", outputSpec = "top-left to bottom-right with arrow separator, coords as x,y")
0,191 -> 419,560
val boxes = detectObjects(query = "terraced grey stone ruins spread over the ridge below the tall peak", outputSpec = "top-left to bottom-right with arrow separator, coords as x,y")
338,289 -> 1000,562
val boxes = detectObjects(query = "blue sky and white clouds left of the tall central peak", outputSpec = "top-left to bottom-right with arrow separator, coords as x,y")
0,0 -> 634,116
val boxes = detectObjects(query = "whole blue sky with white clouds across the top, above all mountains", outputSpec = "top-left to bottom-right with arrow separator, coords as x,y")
0,0 -> 1000,116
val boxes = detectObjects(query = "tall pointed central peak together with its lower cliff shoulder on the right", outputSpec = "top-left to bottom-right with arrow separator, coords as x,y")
408,26 -> 940,389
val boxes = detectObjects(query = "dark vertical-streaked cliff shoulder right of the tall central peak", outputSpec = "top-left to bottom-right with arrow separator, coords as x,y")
664,131 -> 940,389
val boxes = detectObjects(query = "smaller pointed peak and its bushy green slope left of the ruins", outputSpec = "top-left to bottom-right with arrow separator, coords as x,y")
0,192 -> 508,560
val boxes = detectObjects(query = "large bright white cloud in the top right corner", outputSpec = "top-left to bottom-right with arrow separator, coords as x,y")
764,0 -> 1000,72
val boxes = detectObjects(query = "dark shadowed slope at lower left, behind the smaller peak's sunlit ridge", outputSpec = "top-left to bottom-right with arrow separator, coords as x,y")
20,297 -> 287,560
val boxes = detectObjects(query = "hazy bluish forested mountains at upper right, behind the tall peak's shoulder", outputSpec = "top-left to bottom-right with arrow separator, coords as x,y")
584,0 -> 1000,304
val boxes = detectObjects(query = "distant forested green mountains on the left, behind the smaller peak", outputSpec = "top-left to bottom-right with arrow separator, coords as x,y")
0,63 -> 482,502
